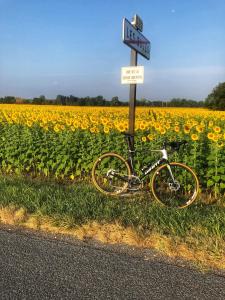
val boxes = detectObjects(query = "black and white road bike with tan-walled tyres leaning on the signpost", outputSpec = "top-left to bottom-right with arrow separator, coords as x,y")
92,133 -> 199,208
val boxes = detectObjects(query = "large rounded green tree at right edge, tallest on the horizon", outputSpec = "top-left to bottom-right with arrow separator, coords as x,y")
205,82 -> 225,110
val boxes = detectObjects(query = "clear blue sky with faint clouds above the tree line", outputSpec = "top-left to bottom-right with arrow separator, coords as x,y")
0,0 -> 225,100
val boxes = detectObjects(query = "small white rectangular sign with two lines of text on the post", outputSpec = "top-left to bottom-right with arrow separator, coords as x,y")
121,66 -> 144,84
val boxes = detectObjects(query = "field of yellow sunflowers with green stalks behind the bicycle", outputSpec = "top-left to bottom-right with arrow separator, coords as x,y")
0,104 -> 225,196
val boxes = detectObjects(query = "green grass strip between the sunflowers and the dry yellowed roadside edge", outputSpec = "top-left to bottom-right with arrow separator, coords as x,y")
0,176 -> 225,247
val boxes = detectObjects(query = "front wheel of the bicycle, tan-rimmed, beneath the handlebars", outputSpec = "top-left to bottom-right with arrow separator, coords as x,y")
152,162 -> 199,208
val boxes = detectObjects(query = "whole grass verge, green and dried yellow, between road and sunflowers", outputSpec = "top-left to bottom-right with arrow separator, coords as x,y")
0,175 -> 225,269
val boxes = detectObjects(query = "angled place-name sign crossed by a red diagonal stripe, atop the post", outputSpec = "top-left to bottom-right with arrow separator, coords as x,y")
123,18 -> 150,59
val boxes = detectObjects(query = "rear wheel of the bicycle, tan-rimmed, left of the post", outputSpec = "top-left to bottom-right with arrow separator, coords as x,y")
92,152 -> 131,195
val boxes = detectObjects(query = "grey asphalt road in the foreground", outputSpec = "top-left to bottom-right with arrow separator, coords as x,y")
0,225 -> 225,300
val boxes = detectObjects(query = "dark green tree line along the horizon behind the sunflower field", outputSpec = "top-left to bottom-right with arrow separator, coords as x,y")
0,82 -> 225,110
